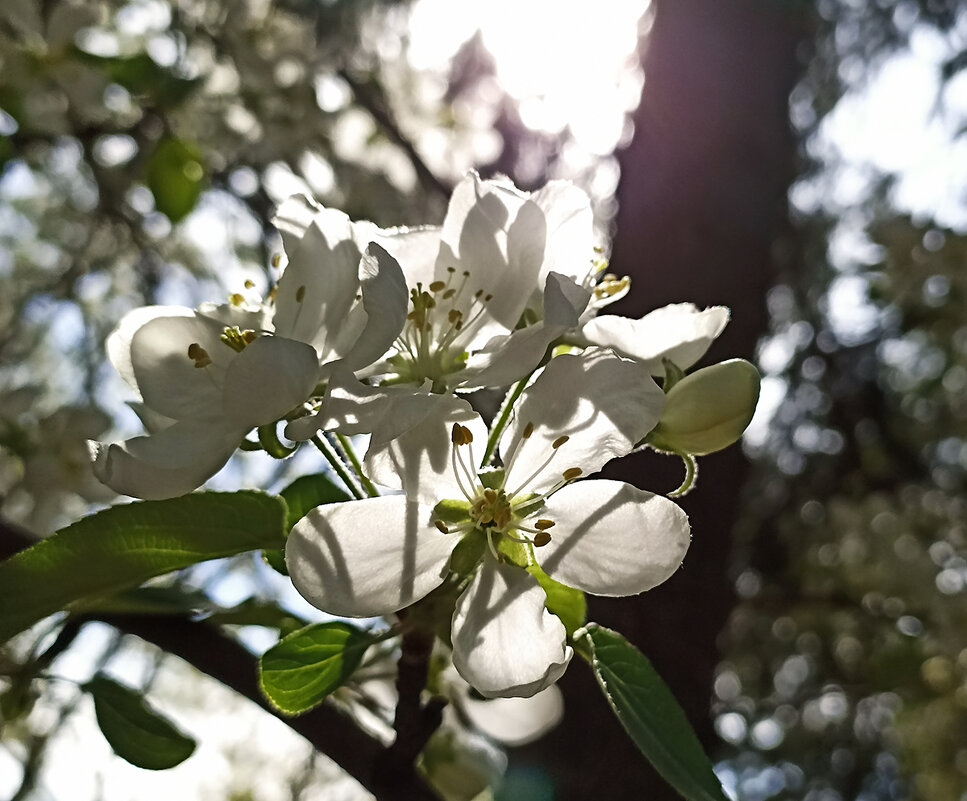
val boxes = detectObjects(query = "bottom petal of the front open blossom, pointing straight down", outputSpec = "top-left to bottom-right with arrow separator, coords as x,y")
453,557 -> 572,698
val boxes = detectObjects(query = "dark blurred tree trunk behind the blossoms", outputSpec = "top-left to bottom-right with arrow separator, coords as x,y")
505,0 -> 808,801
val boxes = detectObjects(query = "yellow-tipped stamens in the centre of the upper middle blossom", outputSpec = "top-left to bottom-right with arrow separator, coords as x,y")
390,267 -> 493,392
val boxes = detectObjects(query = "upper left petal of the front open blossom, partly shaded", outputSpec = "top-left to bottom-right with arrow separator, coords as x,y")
365,395 -> 487,506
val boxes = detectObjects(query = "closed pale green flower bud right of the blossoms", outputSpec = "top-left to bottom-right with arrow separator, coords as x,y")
647,359 -> 760,456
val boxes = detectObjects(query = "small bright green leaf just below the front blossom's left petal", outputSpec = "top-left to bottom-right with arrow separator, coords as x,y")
259,622 -> 373,715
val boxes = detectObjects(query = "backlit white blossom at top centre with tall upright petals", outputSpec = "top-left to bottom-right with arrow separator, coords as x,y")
286,173 -> 594,439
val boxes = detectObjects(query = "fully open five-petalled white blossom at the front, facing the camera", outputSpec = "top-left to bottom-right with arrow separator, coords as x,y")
286,348 -> 689,697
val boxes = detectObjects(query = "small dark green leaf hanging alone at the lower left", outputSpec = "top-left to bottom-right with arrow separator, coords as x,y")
84,676 -> 195,770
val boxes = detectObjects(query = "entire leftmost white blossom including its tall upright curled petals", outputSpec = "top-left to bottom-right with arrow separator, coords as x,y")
91,197 -> 406,499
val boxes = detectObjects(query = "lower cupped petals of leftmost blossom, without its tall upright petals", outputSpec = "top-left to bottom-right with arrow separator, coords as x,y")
90,306 -> 319,499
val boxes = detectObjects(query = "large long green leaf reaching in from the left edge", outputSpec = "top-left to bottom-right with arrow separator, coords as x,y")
0,492 -> 285,642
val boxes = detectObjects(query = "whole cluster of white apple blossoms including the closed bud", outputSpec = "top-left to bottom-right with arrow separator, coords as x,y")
92,174 -> 758,697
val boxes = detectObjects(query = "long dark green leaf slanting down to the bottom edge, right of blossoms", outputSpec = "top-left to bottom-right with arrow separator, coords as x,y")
585,623 -> 727,801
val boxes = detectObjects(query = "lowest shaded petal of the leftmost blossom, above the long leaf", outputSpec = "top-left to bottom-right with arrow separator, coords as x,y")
89,421 -> 242,500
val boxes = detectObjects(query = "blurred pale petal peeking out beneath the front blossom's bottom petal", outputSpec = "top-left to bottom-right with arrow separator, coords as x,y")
460,685 -> 564,746
